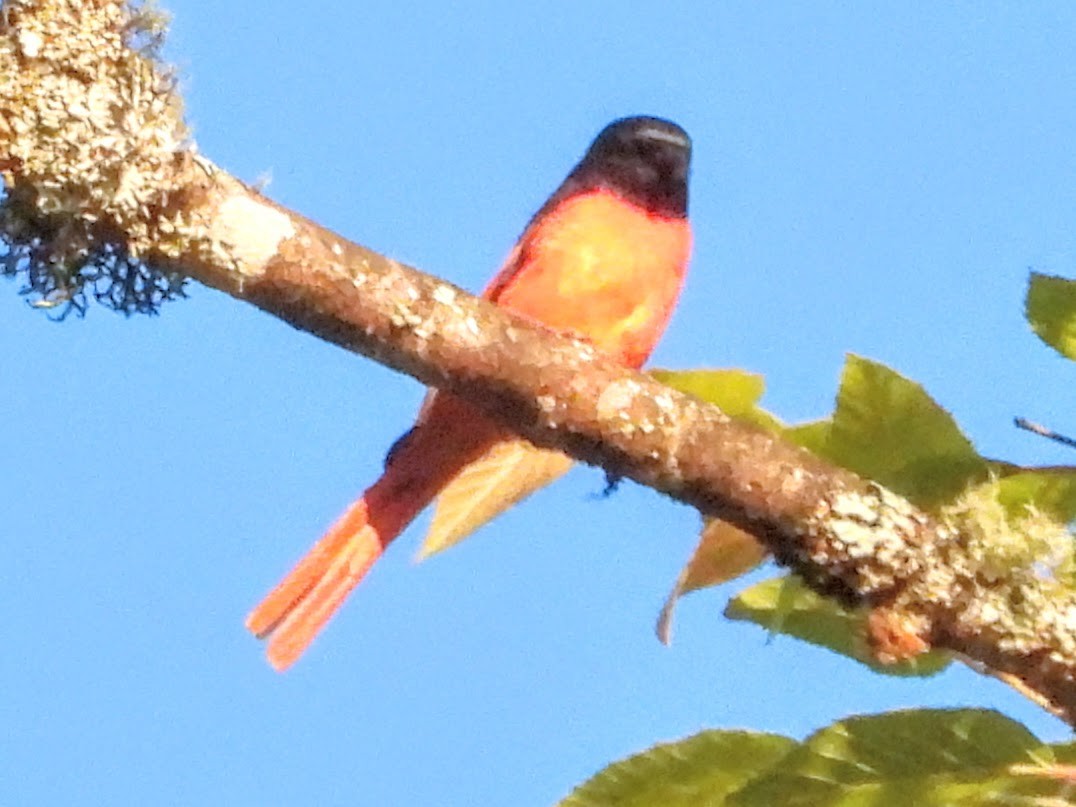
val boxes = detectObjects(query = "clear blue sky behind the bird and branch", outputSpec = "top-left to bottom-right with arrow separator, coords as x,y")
0,0 -> 1076,805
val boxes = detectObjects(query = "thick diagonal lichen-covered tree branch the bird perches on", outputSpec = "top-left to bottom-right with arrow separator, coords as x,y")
6,0 -> 1076,723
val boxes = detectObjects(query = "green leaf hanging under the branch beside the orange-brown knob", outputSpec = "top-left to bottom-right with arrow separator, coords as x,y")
725,576 -> 950,676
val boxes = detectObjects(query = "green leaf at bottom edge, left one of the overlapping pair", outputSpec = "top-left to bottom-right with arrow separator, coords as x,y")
558,731 -> 796,807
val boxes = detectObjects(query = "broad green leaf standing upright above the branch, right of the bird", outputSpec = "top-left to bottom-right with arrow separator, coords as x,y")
823,356 -> 987,508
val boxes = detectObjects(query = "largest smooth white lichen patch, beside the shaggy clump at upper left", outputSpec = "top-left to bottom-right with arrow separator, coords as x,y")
208,194 -> 295,277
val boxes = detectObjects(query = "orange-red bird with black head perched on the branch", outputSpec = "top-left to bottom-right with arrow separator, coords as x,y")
246,115 -> 692,670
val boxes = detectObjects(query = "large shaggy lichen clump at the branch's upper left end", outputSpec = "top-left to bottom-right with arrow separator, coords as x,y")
0,0 -> 186,313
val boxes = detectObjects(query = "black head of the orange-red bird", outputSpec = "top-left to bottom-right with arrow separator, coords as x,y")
566,116 -> 691,218
